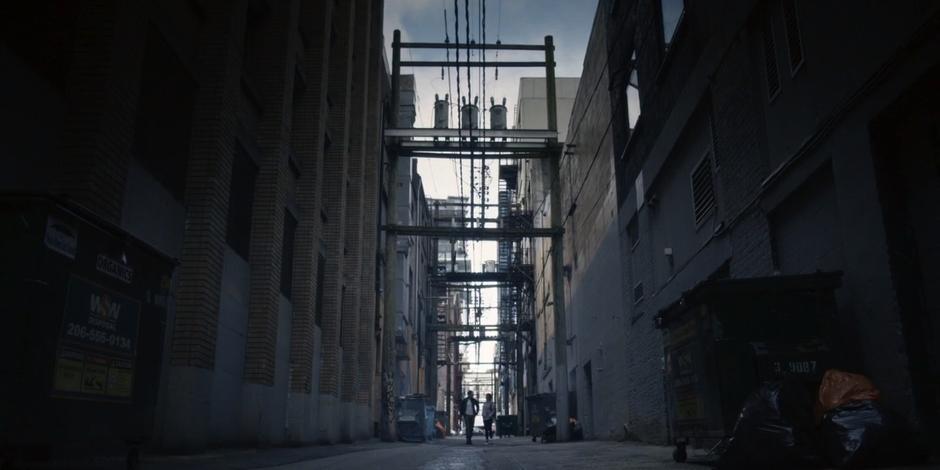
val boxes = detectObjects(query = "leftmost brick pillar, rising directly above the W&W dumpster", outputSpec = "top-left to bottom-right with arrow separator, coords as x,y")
54,0 -> 147,223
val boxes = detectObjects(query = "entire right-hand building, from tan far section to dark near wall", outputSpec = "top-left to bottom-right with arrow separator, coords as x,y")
562,0 -> 940,442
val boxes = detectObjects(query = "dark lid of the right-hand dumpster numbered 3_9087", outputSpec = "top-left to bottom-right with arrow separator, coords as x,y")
656,271 -> 842,328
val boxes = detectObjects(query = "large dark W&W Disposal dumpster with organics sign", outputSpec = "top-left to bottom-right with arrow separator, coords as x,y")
0,196 -> 175,467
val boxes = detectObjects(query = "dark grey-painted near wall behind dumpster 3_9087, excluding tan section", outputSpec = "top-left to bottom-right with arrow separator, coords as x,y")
586,0 -> 938,442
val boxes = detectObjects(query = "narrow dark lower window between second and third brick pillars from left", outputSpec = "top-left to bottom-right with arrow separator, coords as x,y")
225,143 -> 258,260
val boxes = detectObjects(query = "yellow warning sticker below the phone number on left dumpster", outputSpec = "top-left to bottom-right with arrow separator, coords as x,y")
53,347 -> 134,401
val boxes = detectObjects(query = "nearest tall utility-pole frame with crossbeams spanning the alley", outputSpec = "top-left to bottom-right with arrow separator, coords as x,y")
381,30 -> 568,440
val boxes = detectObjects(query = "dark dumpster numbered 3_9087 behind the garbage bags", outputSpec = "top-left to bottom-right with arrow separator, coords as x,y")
656,272 -> 842,459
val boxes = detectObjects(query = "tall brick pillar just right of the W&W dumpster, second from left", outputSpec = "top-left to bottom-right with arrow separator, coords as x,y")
170,1 -> 245,369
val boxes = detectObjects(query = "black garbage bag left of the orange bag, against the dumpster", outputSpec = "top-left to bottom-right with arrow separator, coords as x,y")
718,380 -> 822,469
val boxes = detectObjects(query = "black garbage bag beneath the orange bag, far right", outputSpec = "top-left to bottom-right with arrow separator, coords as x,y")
819,400 -> 927,468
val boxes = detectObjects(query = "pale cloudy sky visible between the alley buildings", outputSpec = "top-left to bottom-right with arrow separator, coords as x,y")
384,0 -> 597,391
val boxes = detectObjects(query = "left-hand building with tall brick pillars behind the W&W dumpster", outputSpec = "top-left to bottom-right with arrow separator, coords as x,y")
0,0 -> 388,450
